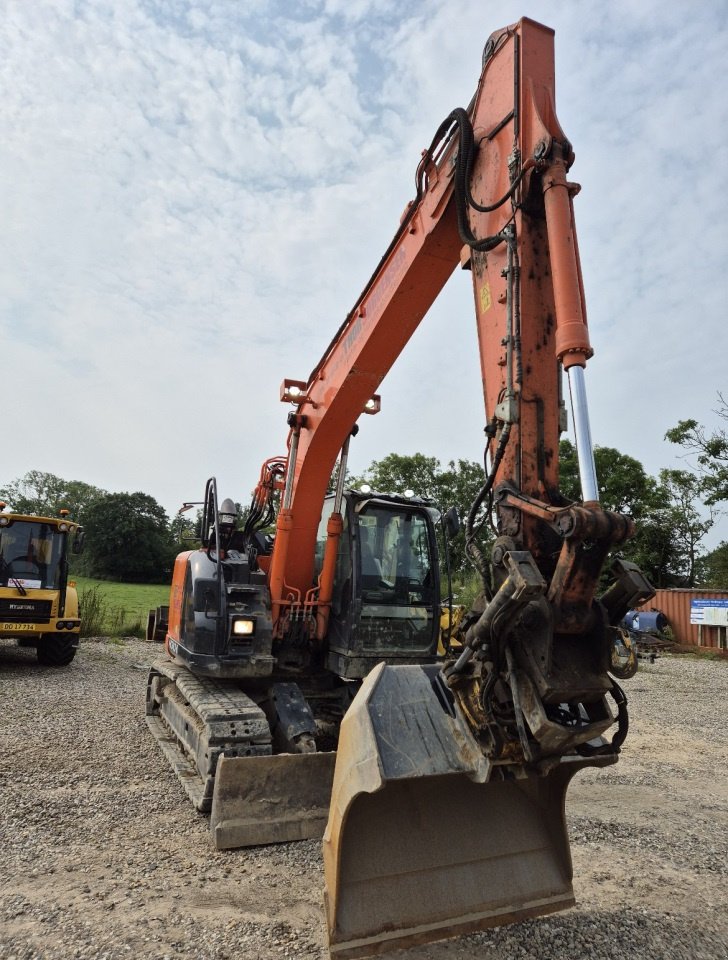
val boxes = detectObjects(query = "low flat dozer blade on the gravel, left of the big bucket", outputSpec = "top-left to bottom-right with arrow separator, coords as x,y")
210,753 -> 335,850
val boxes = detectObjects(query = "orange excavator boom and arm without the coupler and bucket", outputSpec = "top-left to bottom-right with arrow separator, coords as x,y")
270,19 -> 628,636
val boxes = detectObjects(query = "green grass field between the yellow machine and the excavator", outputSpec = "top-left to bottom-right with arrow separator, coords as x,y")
70,577 -> 169,637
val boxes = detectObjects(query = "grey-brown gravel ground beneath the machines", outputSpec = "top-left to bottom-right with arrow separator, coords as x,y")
0,640 -> 728,960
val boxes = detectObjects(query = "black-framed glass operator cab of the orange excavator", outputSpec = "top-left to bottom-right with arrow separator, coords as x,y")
316,490 -> 440,679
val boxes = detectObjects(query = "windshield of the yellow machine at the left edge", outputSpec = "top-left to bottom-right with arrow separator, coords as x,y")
0,520 -> 65,589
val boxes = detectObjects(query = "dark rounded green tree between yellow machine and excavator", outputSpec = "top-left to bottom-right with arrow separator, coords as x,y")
85,493 -> 175,583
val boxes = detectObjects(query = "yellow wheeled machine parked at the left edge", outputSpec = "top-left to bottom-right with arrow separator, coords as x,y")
0,502 -> 83,667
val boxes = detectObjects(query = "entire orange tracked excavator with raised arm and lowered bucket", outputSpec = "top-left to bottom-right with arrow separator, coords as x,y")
147,19 -> 652,958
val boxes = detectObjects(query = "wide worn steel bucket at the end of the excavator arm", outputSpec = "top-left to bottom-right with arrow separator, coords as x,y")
324,664 -> 596,960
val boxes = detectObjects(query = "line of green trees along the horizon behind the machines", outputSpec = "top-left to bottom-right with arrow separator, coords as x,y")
0,395 -> 728,589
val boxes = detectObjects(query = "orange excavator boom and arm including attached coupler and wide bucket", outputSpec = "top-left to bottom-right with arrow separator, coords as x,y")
316,19 -> 652,958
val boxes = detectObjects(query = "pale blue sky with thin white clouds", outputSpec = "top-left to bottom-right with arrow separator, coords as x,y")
0,0 -> 728,539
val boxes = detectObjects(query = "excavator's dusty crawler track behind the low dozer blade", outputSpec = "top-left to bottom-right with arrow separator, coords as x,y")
146,660 -> 273,813
